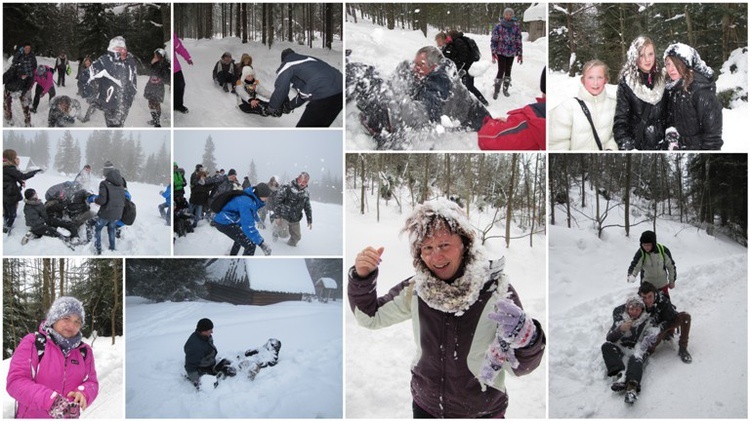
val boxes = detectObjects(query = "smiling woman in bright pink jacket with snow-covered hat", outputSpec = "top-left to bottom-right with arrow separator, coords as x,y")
7,297 -> 99,418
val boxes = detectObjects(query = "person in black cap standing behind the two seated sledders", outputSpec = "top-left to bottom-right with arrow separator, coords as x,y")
628,231 -> 677,297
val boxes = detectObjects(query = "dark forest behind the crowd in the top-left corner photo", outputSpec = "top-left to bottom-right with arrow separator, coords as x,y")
3,2 -> 172,64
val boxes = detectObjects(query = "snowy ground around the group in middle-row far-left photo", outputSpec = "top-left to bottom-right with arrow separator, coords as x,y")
3,172 -> 172,257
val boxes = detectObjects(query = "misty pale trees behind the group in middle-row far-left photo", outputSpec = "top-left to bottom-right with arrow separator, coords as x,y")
3,130 -> 171,184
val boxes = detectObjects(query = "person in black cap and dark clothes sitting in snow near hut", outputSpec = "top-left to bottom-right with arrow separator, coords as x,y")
183,318 -> 237,390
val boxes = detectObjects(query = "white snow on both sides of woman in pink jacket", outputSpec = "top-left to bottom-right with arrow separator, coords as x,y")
0,336 -> 125,419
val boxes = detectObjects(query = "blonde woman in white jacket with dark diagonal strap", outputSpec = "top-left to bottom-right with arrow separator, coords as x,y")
549,60 -> 618,151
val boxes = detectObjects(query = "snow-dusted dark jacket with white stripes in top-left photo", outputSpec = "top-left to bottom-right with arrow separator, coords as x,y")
81,51 -> 138,110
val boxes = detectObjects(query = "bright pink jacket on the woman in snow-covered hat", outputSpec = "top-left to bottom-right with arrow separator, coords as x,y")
6,326 -> 99,418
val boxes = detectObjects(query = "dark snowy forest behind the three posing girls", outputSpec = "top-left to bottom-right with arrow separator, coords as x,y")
548,2 -> 747,83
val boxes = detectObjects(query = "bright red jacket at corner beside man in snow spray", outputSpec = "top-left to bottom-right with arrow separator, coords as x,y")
478,98 -> 547,151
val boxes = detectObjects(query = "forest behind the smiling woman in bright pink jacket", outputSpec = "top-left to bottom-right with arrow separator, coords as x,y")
3,258 -> 123,359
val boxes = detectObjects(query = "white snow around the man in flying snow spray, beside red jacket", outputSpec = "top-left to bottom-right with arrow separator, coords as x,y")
344,18 -> 547,150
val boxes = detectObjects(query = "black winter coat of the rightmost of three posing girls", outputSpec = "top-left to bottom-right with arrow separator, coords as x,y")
665,72 -> 724,150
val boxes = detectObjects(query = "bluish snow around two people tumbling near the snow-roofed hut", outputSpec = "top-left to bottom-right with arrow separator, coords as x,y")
125,296 -> 343,419
